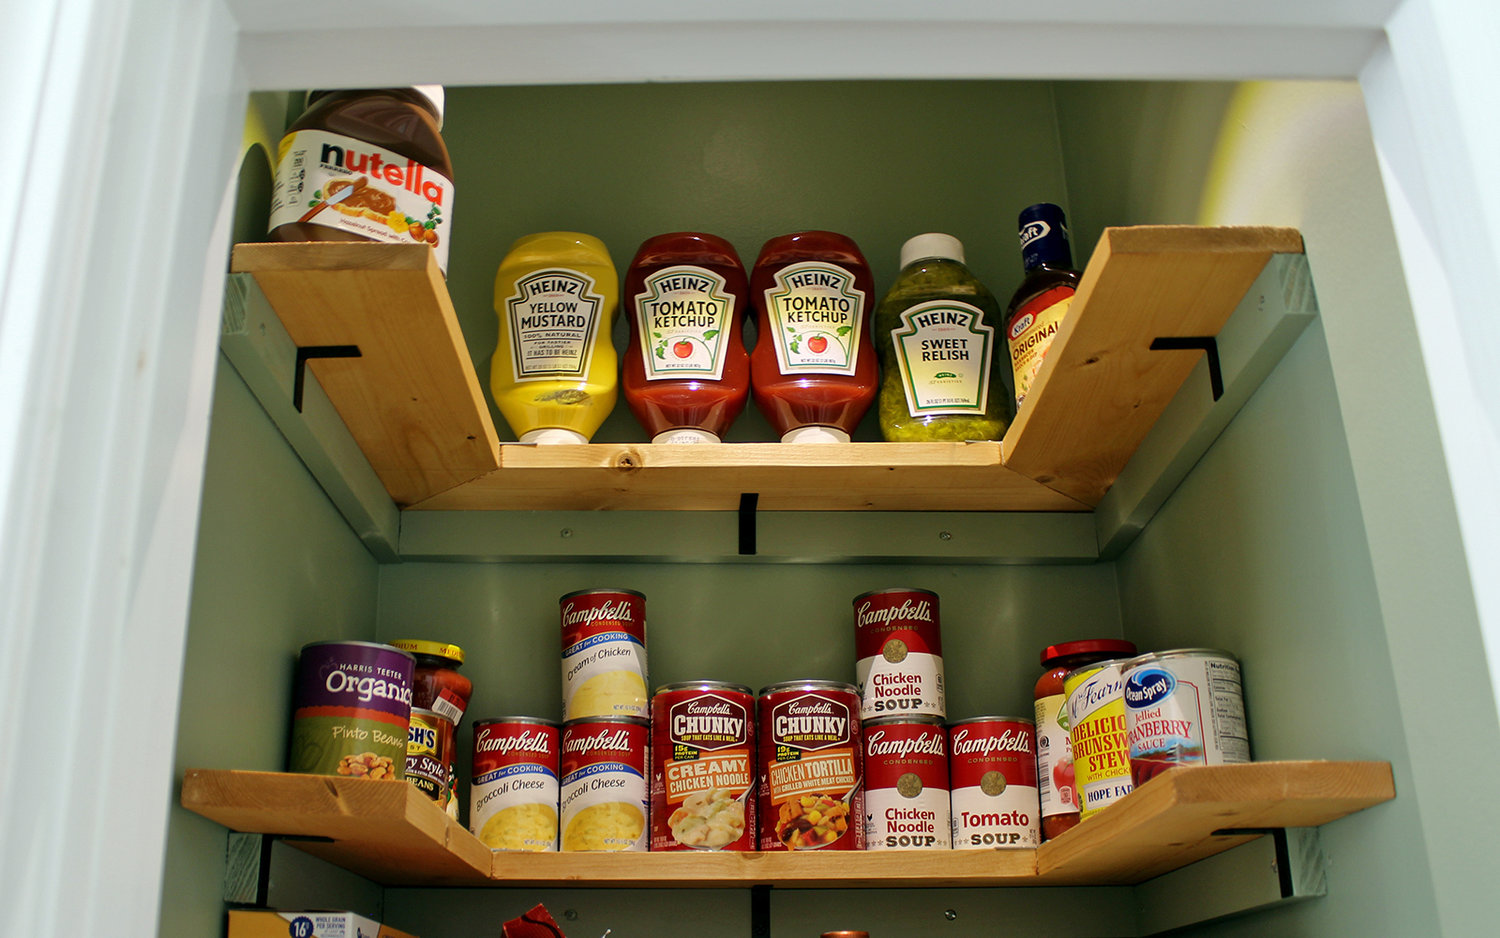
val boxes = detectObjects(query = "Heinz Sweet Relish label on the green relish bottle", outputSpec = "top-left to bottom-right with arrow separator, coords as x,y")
891,300 -> 995,417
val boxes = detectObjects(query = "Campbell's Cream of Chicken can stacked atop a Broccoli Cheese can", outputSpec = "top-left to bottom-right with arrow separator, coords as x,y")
558,590 -> 651,720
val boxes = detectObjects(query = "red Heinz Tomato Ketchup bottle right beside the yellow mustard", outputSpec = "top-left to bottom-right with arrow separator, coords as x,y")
621,231 -> 750,443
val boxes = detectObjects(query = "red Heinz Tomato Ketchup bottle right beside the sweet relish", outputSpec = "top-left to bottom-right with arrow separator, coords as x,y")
750,231 -> 879,443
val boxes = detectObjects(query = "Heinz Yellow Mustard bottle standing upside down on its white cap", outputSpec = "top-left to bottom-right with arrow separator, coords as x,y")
489,231 -> 620,443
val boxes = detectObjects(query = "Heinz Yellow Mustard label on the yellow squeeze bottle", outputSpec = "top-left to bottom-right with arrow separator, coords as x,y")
506,267 -> 605,381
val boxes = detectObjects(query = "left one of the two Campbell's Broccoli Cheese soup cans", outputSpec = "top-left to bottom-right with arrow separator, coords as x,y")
470,716 -> 560,852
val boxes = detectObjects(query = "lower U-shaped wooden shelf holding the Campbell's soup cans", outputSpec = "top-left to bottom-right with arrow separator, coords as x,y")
182,762 -> 1395,888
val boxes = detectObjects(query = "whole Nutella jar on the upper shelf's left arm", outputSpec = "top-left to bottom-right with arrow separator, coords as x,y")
267,86 -> 453,275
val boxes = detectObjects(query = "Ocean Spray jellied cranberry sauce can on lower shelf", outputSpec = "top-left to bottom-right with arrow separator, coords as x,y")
1122,648 -> 1250,785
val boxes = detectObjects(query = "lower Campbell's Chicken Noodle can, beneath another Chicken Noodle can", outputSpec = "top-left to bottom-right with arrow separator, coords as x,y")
861,716 -> 953,849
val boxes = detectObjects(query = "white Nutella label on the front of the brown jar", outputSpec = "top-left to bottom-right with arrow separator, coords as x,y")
270,131 -> 453,273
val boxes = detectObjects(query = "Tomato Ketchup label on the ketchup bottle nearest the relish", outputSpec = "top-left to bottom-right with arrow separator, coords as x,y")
765,261 -> 864,375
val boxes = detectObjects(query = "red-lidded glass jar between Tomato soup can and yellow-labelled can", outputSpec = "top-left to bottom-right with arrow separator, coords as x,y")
1034,638 -> 1136,840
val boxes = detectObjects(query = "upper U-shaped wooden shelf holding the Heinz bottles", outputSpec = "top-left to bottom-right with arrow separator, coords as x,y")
231,227 -> 1302,512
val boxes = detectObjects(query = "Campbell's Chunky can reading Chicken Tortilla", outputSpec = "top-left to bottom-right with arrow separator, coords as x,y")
758,681 -> 864,849
